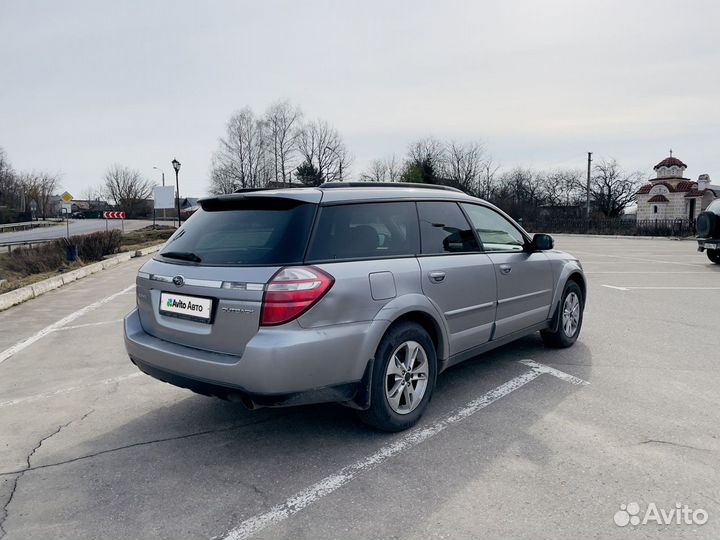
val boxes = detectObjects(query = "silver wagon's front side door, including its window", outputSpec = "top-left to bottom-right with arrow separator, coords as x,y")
462,203 -> 554,339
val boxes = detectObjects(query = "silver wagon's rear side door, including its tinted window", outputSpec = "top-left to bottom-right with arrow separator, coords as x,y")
417,201 -> 496,355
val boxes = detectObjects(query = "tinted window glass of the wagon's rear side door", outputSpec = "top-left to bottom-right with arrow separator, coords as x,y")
417,201 -> 480,254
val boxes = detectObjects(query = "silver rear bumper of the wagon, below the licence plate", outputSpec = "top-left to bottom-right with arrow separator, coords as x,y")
124,310 -> 374,406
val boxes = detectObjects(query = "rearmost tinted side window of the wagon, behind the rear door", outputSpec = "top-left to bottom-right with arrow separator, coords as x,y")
307,202 -> 420,262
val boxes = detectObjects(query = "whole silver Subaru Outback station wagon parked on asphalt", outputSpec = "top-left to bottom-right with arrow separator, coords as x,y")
124,183 -> 587,431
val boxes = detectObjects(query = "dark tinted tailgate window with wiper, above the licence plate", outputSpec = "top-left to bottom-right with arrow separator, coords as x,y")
160,197 -> 316,266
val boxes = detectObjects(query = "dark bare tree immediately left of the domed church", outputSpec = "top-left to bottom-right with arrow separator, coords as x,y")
590,159 -> 642,217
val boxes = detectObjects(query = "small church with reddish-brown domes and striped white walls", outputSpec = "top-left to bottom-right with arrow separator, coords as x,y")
636,150 -> 720,223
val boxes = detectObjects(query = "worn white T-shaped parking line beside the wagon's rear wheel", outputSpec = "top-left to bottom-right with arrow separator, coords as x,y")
223,360 -> 589,540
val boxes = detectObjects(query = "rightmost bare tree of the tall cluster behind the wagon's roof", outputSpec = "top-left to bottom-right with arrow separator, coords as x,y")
297,120 -> 350,183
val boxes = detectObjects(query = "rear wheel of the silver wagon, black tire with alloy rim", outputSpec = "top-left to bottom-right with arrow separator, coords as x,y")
358,322 -> 437,432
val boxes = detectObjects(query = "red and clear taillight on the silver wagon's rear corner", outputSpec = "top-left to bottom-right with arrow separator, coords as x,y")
260,266 -> 335,326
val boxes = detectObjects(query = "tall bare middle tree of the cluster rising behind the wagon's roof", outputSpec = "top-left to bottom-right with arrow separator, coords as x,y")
264,101 -> 302,184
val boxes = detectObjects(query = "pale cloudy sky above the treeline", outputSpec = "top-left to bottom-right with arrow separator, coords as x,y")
0,0 -> 720,196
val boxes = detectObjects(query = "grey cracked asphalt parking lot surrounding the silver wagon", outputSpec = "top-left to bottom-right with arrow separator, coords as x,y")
0,235 -> 720,540
